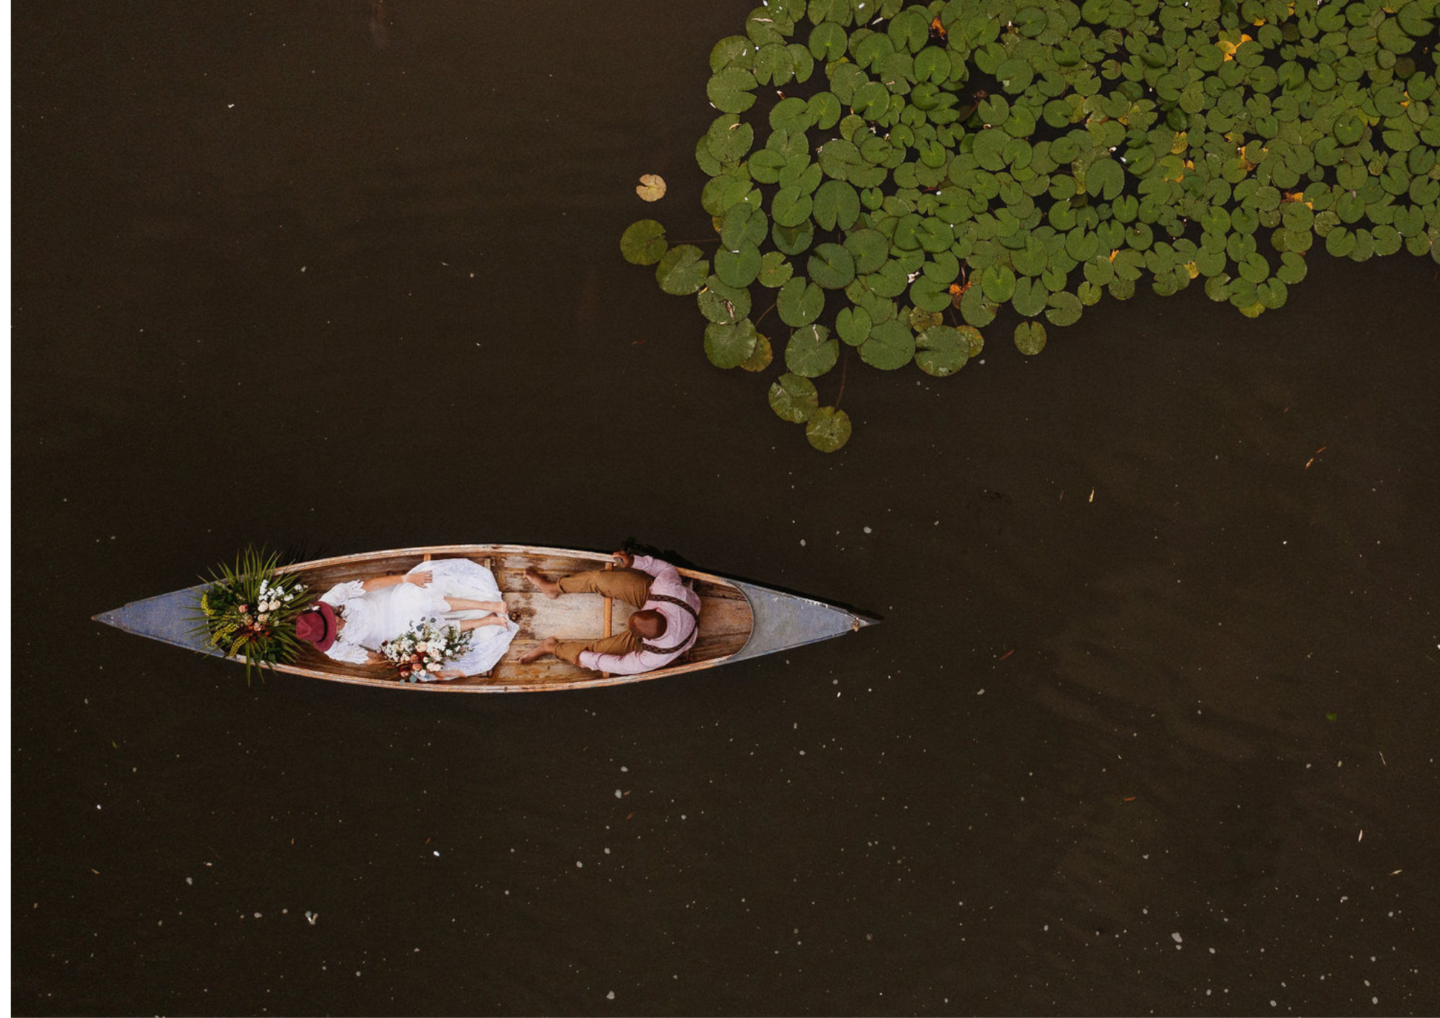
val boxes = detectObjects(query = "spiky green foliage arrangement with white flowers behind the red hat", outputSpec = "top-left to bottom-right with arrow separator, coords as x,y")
196,549 -> 311,678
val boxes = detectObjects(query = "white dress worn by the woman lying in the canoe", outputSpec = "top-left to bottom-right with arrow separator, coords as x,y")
320,559 -> 520,675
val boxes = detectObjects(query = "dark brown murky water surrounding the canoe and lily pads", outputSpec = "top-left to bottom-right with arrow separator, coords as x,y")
12,0 -> 1440,1014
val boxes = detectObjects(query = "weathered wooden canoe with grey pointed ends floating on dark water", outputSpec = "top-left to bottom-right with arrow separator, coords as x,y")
95,544 -> 874,693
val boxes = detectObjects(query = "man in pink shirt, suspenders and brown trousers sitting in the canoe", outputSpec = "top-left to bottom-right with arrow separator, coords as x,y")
520,551 -> 700,675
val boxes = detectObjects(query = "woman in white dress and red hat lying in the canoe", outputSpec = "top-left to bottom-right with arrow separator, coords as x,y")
295,559 -> 520,678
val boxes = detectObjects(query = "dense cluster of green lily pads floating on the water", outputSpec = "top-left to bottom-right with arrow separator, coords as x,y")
621,0 -> 1440,451
